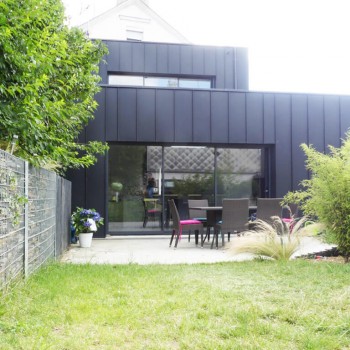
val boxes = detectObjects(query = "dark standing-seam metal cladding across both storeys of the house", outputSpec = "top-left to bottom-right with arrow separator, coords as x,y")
66,42 -> 350,238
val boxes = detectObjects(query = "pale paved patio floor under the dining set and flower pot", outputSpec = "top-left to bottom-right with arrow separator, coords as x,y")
61,236 -> 333,265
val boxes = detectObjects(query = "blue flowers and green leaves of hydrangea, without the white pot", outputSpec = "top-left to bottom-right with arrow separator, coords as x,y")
71,207 -> 103,235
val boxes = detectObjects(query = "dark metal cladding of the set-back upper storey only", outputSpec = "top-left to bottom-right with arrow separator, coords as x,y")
100,40 -> 248,90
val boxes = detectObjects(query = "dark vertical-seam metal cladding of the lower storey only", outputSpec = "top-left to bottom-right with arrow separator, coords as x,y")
87,87 -> 350,200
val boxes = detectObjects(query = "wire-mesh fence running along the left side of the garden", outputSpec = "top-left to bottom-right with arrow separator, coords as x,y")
0,150 -> 71,289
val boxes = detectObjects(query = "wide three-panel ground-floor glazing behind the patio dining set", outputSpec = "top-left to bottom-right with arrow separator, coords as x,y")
108,145 -> 264,234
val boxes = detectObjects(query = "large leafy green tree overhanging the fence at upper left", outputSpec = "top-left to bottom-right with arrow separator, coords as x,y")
0,0 -> 107,172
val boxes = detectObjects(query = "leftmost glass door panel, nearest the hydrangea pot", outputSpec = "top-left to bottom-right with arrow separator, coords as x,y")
108,145 -> 162,234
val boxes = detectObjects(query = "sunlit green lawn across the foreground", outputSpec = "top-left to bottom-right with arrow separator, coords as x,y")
0,260 -> 350,350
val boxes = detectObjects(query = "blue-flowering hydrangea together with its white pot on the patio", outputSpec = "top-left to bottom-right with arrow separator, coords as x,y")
71,207 -> 103,248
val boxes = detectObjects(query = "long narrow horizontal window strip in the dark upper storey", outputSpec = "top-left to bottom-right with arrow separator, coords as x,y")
108,74 -> 212,89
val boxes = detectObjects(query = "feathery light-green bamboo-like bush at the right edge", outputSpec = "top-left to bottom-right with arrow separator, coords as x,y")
284,132 -> 350,261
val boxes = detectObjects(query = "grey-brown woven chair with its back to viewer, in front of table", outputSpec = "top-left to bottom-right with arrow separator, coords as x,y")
211,198 -> 249,249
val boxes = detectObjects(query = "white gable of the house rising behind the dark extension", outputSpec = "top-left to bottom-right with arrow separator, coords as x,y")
79,0 -> 190,44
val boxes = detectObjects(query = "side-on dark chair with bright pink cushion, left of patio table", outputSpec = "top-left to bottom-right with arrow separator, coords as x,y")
168,199 -> 203,248
